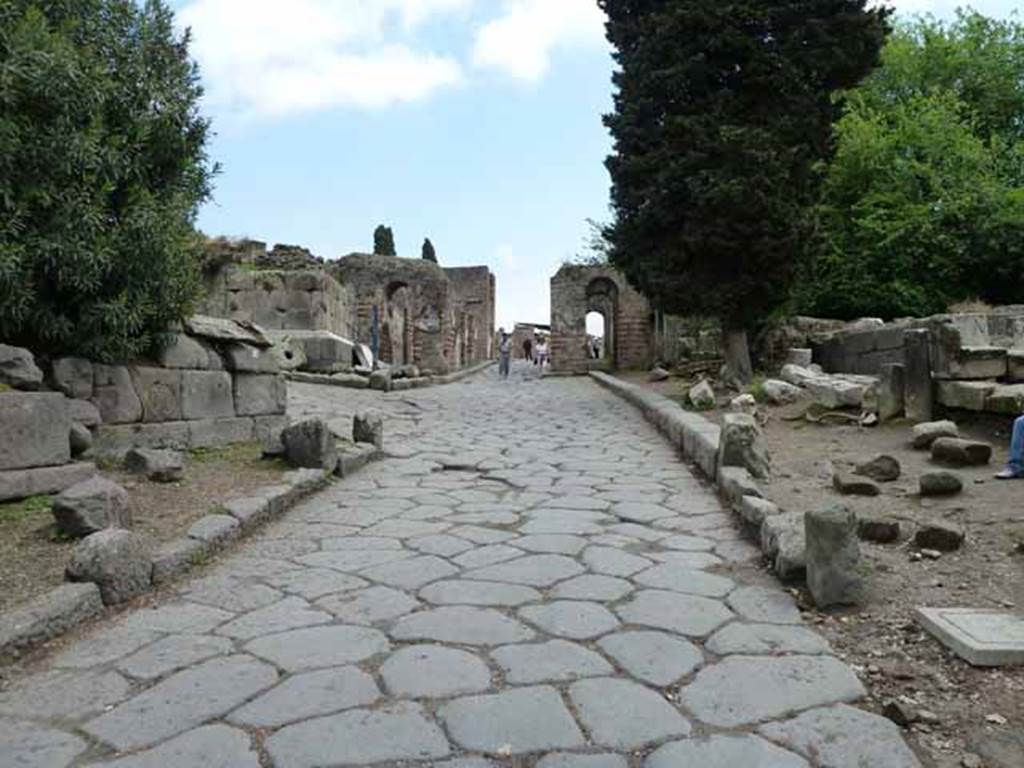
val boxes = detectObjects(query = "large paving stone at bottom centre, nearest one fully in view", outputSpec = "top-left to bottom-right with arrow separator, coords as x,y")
438,686 -> 585,755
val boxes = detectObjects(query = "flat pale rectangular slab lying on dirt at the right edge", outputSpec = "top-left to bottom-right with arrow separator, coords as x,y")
915,607 -> 1024,667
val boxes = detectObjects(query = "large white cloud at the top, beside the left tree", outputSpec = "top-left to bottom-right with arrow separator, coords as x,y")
178,0 -> 472,115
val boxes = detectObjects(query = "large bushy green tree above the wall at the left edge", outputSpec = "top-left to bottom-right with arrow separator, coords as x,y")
0,0 -> 216,360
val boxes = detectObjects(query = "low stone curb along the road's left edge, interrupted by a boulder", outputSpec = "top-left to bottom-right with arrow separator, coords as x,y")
0,454 -> 381,660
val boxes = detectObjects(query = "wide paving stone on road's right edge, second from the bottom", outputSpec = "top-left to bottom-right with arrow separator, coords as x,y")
681,656 -> 865,728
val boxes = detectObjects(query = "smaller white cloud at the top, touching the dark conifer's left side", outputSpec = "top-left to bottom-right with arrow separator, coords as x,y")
473,0 -> 604,81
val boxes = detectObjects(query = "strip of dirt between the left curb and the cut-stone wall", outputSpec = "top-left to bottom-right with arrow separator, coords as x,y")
0,443 -> 289,611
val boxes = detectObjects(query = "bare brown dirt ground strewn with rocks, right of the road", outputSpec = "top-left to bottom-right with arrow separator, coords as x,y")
627,375 -> 1024,768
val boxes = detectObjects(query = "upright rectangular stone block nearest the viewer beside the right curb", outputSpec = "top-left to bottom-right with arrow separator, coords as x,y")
804,506 -> 862,608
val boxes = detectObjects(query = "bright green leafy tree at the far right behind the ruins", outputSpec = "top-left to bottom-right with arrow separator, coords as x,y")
793,11 -> 1024,318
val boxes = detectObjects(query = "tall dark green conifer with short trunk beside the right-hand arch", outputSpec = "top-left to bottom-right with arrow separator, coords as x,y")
599,0 -> 888,380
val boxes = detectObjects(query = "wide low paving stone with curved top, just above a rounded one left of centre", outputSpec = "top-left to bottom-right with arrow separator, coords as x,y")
391,605 -> 535,645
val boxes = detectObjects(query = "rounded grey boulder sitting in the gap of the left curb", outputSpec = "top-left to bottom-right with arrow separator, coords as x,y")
68,528 -> 153,605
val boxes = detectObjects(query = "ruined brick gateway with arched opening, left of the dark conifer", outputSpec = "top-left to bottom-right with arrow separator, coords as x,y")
551,264 -> 653,373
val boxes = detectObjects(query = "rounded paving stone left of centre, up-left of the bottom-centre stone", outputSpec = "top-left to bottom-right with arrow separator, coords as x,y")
380,645 -> 490,698
